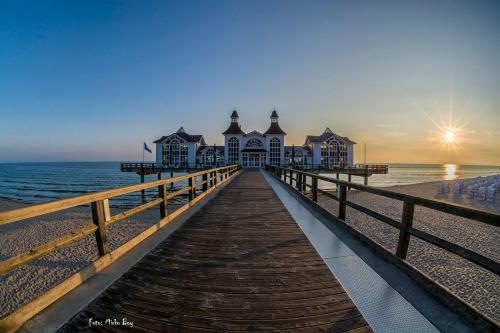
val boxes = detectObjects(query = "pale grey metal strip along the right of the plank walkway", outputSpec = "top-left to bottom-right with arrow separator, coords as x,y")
263,172 -> 439,333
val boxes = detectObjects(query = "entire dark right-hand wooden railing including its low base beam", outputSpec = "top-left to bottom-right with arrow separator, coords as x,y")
266,165 -> 500,332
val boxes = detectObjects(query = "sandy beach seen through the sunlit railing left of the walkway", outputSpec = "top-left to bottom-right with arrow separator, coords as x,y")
0,199 -> 178,316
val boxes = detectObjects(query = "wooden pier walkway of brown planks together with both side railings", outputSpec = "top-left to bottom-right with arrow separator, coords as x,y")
0,165 -> 500,333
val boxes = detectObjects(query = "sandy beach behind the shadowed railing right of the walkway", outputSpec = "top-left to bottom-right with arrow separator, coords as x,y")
318,182 -> 500,322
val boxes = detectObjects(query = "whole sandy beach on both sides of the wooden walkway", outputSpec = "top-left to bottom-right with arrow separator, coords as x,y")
0,182 -> 500,321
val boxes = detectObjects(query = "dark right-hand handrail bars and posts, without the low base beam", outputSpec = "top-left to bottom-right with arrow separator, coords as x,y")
266,165 -> 500,275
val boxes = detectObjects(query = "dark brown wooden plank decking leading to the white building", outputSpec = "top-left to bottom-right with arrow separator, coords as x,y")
60,171 -> 371,333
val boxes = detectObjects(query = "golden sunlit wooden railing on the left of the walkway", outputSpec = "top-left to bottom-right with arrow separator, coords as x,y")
0,165 -> 241,331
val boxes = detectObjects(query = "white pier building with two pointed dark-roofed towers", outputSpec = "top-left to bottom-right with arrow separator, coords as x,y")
154,110 -> 356,168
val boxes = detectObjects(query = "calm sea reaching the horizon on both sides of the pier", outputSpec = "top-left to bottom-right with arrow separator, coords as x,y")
0,162 -> 500,207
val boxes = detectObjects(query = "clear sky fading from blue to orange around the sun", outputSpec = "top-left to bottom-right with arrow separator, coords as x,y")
0,1 -> 500,165
